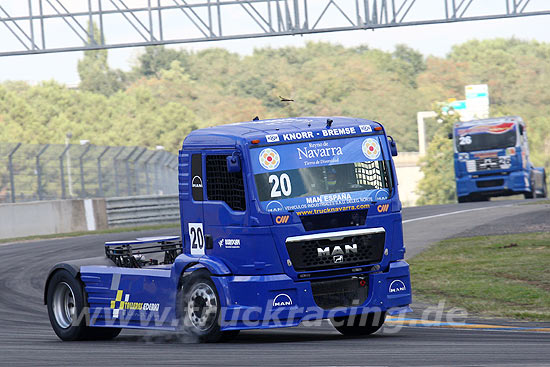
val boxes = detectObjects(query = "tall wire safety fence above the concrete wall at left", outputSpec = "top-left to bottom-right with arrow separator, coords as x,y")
0,143 -> 178,203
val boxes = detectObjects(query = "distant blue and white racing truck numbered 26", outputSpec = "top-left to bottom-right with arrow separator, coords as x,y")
449,116 -> 547,203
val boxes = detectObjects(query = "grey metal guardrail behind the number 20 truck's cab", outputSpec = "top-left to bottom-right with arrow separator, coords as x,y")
109,195 -> 180,227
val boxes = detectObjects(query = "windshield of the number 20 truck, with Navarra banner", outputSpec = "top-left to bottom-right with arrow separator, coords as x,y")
250,136 -> 392,211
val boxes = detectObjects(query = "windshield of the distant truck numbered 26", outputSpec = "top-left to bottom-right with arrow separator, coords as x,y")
455,122 -> 516,152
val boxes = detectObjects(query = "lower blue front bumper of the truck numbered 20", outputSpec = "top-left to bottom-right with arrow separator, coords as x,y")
213,261 -> 412,330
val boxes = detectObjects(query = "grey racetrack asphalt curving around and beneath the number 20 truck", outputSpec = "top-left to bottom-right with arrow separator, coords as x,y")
0,201 -> 550,366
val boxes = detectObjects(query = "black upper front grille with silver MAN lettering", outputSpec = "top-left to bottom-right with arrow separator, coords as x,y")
286,230 -> 386,271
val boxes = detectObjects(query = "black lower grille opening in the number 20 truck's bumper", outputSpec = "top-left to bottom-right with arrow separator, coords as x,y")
311,277 -> 369,309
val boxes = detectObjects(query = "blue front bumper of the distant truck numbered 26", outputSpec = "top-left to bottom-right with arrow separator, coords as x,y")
456,171 -> 530,196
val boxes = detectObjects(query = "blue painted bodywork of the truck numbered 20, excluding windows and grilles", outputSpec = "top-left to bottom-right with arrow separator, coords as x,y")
80,117 -> 412,330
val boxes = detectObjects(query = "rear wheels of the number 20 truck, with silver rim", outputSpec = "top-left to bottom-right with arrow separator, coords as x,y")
46,270 -> 121,341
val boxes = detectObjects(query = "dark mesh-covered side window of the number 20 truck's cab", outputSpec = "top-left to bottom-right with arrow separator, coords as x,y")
206,154 -> 246,211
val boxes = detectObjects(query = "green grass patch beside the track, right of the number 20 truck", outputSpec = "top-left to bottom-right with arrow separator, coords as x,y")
410,232 -> 550,321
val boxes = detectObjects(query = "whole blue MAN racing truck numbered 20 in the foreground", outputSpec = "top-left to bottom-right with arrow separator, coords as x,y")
44,117 -> 411,342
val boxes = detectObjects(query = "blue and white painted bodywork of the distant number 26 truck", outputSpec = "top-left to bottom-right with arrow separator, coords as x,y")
453,116 -> 545,198
